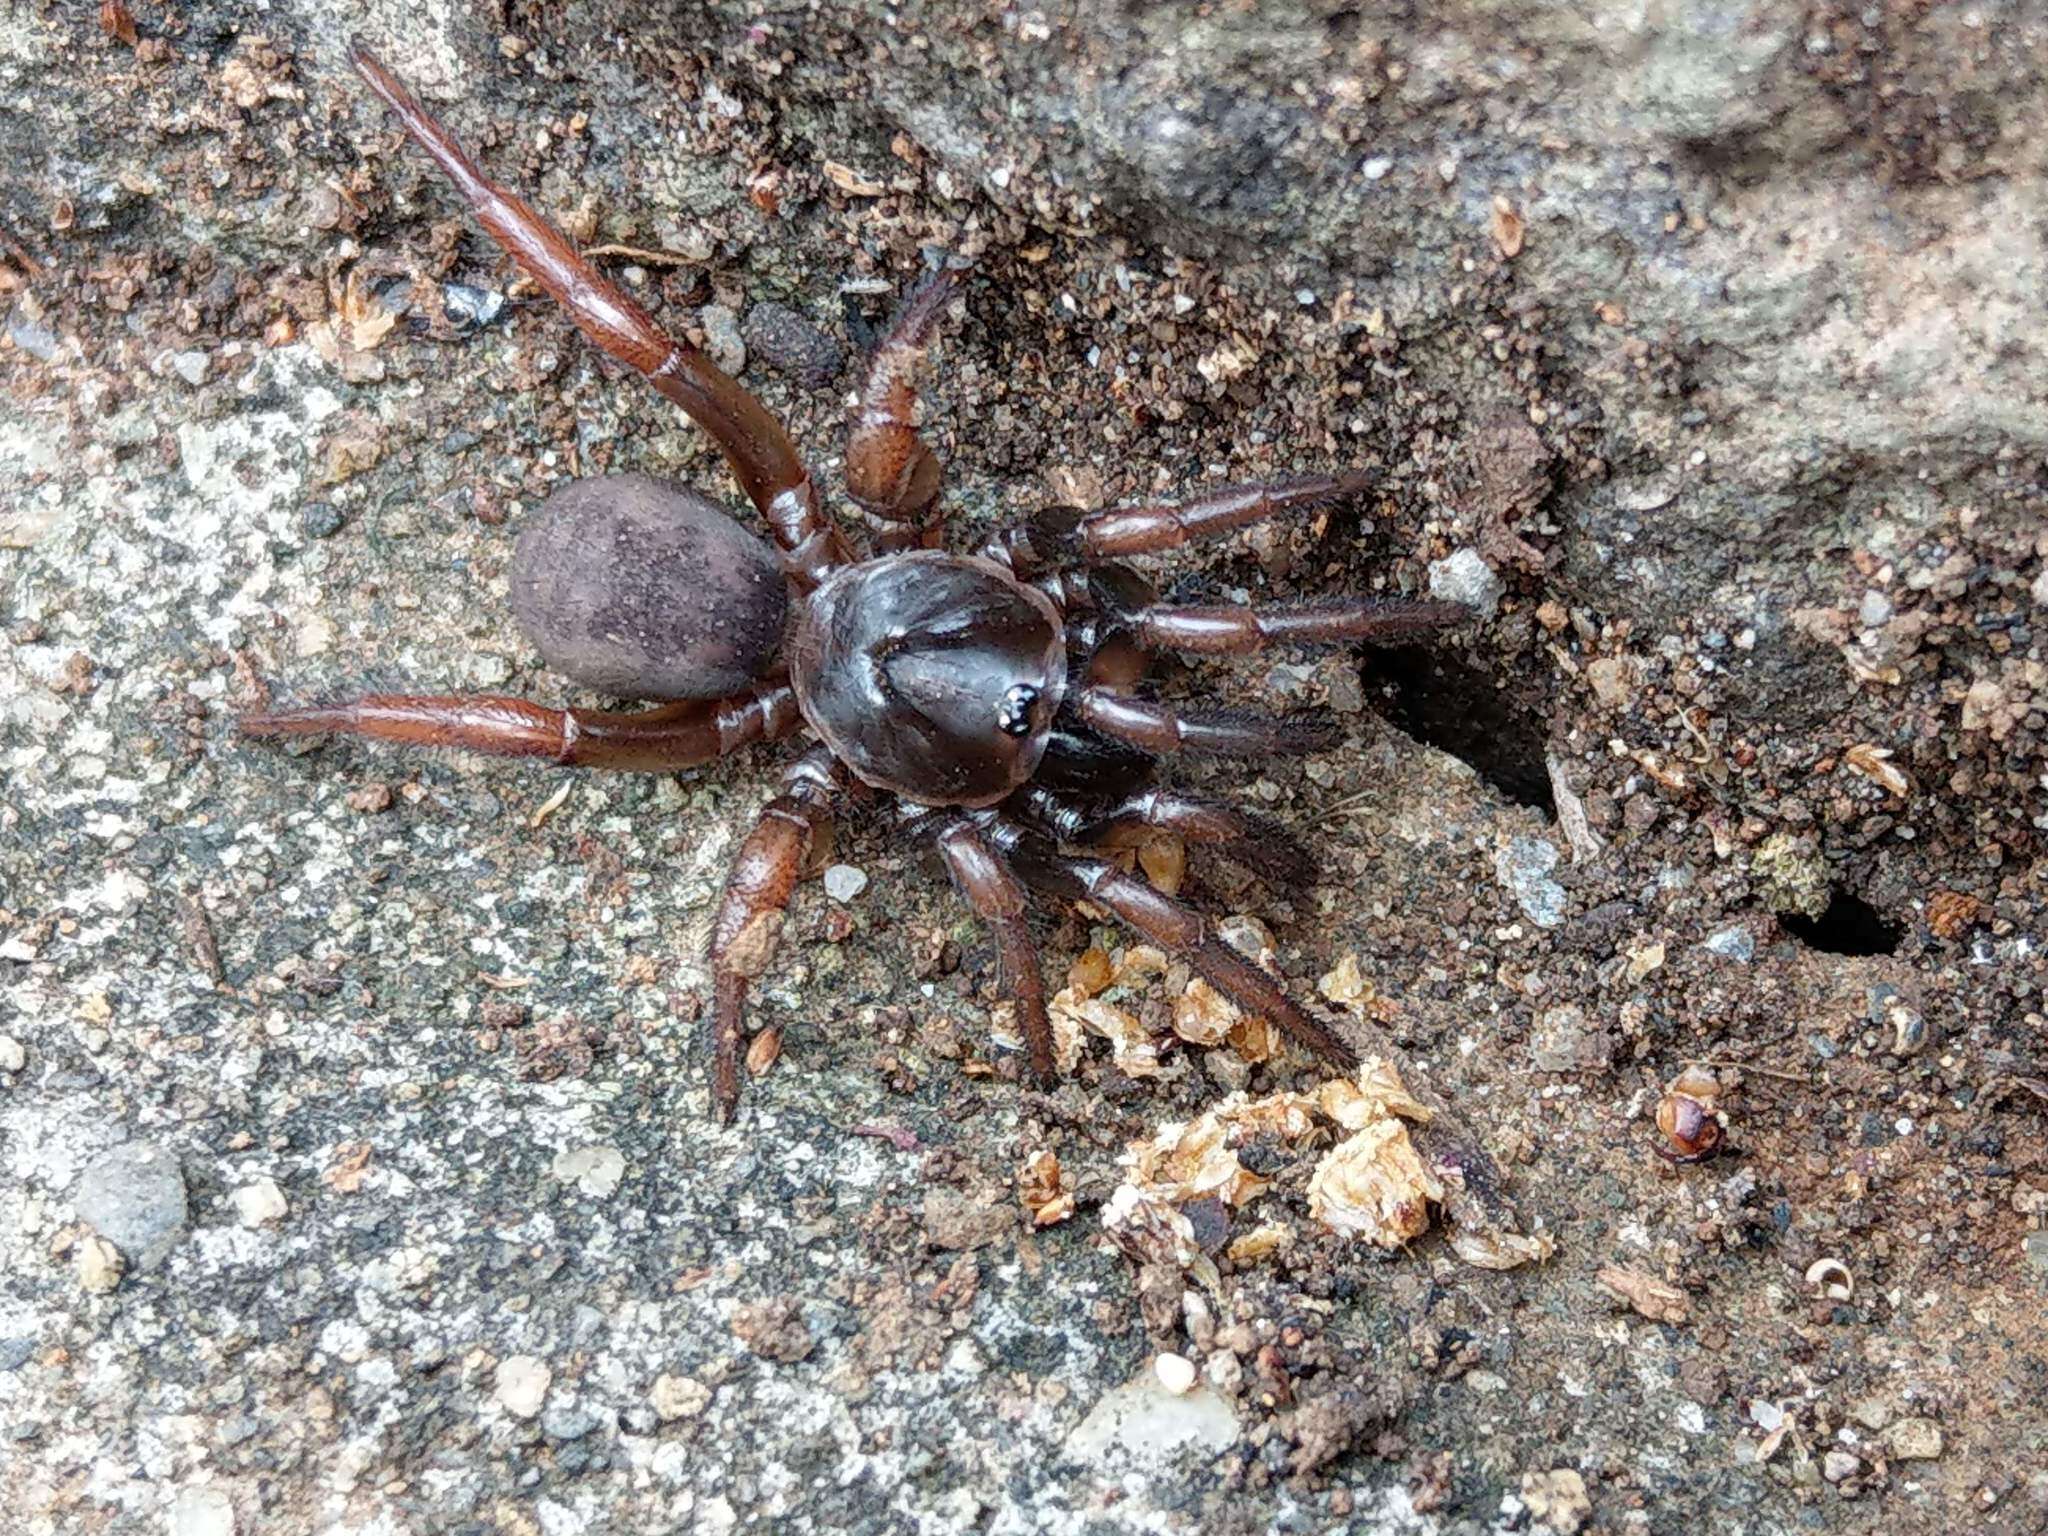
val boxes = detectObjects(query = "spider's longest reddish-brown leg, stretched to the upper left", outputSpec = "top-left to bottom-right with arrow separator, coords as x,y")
350,39 -> 852,586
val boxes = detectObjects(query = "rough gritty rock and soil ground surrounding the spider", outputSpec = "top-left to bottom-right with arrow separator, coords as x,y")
0,0 -> 2048,1536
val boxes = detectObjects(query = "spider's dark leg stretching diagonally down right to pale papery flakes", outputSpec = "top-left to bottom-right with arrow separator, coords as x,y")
989,819 -> 1358,1067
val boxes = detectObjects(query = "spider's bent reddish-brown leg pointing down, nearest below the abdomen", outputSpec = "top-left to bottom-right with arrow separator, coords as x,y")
711,745 -> 842,1124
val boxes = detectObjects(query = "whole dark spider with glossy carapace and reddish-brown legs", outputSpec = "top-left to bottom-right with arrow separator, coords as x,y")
240,41 -> 1468,1124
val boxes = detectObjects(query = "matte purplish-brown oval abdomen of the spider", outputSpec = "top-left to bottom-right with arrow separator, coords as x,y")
510,475 -> 788,698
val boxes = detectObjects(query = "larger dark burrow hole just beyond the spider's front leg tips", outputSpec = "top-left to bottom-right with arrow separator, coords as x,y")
1366,647 -> 1556,817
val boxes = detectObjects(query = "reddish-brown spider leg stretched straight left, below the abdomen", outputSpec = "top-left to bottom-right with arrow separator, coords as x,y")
238,678 -> 803,774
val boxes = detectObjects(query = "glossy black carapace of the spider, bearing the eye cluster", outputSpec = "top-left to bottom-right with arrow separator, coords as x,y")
788,551 -> 1067,819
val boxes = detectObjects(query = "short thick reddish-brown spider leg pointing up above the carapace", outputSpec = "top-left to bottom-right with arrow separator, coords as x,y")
846,268 -> 956,549
